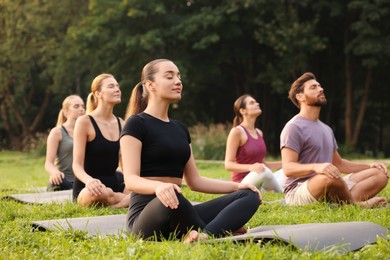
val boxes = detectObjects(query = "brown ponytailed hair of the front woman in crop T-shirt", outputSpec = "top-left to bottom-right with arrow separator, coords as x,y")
125,59 -> 172,119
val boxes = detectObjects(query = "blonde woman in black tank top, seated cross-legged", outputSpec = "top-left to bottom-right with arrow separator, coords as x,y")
73,74 -> 130,208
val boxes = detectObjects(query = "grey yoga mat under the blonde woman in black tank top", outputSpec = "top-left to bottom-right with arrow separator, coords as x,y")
3,190 -> 72,204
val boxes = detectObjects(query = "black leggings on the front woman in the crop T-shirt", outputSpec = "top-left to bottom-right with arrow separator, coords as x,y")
127,189 -> 260,240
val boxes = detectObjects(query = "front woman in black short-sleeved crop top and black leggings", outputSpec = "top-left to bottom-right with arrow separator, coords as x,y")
120,59 -> 261,243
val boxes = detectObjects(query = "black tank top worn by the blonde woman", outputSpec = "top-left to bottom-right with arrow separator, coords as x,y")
73,115 -> 123,200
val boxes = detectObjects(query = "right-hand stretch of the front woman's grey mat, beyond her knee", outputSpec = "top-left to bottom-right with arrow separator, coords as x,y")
216,222 -> 388,254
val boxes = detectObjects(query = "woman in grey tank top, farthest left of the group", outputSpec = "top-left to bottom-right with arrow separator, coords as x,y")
45,95 -> 85,191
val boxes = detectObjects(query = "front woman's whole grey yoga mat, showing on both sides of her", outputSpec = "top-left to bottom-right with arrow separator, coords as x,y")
31,214 -> 387,253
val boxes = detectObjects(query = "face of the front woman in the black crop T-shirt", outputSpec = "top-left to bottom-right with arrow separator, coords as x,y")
149,61 -> 183,101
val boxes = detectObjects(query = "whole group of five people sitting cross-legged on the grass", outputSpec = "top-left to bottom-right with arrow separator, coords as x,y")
45,59 -> 388,243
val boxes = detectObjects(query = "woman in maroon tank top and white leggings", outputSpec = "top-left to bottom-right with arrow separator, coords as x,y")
225,95 -> 284,193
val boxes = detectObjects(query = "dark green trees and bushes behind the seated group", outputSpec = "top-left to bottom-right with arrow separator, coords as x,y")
0,0 -> 390,156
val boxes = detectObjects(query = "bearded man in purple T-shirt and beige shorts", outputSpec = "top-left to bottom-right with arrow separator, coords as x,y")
280,72 -> 389,207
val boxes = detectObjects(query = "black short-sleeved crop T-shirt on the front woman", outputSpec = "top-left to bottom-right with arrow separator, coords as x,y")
121,112 -> 191,178
